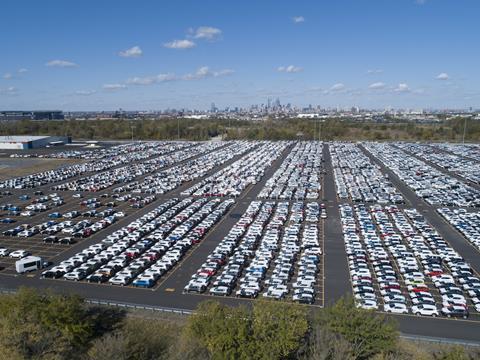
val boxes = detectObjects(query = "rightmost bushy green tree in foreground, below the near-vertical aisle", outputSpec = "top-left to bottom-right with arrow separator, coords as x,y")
316,298 -> 398,359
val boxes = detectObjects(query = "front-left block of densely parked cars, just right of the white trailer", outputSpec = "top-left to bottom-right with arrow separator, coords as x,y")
42,198 -> 233,288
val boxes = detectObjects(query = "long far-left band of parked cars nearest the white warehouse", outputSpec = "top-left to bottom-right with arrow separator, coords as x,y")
0,142 -> 195,190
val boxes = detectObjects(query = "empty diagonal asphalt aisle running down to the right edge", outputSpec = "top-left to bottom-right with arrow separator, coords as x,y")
361,145 -> 480,273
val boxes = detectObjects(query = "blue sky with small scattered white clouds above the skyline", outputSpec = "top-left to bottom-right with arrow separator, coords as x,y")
0,0 -> 480,110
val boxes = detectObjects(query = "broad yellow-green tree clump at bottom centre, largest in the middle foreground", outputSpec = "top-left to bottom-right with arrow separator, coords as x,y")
184,300 -> 308,360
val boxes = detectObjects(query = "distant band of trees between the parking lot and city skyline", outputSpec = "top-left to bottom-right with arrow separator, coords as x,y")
0,117 -> 480,142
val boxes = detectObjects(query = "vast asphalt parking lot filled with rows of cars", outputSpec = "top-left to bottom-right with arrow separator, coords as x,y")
0,141 -> 480,337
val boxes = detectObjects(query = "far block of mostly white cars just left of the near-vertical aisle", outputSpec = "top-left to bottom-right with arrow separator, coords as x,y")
258,141 -> 323,200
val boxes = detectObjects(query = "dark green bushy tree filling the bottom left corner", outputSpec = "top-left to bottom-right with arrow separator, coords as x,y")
0,288 -> 102,359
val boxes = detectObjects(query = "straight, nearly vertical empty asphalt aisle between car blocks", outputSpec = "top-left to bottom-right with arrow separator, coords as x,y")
323,144 -> 352,305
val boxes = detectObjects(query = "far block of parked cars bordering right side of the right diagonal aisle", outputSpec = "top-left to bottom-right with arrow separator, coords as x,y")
364,143 -> 480,207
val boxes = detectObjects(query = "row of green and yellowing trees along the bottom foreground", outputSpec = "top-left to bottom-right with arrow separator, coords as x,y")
0,288 -> 474,360
